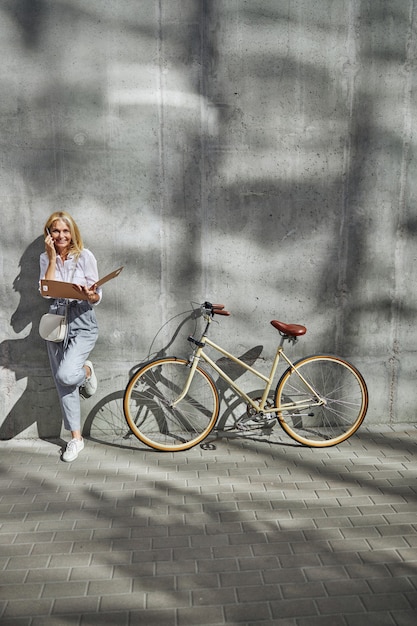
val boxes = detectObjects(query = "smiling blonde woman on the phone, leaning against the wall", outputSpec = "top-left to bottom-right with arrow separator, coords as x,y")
40,211 -> 101,462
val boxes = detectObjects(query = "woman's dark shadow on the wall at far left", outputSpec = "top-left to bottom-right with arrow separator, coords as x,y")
0,237 -> 61,439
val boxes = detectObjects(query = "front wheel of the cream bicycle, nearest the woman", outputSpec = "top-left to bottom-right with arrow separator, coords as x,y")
123,358 -> 219,452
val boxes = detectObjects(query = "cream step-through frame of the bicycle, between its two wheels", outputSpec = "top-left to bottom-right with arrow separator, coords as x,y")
171,320 -> 326,413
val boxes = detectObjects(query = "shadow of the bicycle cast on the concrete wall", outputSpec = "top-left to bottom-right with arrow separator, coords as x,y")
83,310 -> 290,450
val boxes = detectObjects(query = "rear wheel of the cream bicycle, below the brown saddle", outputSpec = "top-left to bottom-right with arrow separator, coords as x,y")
275,355 -> 368,448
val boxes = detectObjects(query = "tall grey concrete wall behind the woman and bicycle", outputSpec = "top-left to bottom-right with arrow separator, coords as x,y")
0,0 -> 417,437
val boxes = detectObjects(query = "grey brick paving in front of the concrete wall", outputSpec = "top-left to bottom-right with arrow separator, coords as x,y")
0,425 -> 417,626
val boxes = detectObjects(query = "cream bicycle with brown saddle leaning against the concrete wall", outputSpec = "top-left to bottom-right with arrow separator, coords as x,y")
123,302 -> 368,452
